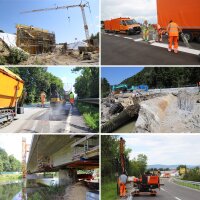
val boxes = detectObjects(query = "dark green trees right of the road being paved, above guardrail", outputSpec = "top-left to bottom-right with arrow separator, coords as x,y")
72,67 -> 99,98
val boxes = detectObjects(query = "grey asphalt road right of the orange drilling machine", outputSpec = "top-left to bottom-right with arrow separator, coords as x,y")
121,179 -> 200,200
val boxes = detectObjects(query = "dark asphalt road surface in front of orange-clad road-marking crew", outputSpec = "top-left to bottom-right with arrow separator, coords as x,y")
101,33 -> 200,65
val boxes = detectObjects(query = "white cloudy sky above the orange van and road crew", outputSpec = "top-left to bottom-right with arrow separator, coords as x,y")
101,0 -> 157,23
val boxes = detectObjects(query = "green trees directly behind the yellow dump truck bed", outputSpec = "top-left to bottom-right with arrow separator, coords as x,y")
9,67 -> 64,103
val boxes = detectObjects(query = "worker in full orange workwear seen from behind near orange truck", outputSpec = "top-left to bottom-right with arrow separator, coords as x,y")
167,20 -> 181,53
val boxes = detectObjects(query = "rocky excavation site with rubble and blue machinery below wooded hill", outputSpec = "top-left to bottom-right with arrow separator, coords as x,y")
101,67 -> 200,133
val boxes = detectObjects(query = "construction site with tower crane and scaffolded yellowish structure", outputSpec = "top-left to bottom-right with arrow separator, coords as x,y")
0,1 -> 99,65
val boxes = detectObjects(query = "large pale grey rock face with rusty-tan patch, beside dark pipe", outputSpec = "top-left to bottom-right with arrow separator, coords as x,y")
135,91 -> 200,133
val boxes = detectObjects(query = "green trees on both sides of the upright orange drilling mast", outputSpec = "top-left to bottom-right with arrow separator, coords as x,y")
101,135 -> 147,181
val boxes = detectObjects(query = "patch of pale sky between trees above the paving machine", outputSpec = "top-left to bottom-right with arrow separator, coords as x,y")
47,66 -> 80,92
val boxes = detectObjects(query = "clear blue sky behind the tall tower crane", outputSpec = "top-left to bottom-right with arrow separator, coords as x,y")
0,0 -> 99,43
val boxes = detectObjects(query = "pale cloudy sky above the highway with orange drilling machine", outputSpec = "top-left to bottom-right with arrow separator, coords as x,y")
120,134 -> 200,165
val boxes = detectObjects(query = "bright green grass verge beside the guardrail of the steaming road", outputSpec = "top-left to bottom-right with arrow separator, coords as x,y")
77,103 -> 99,132
